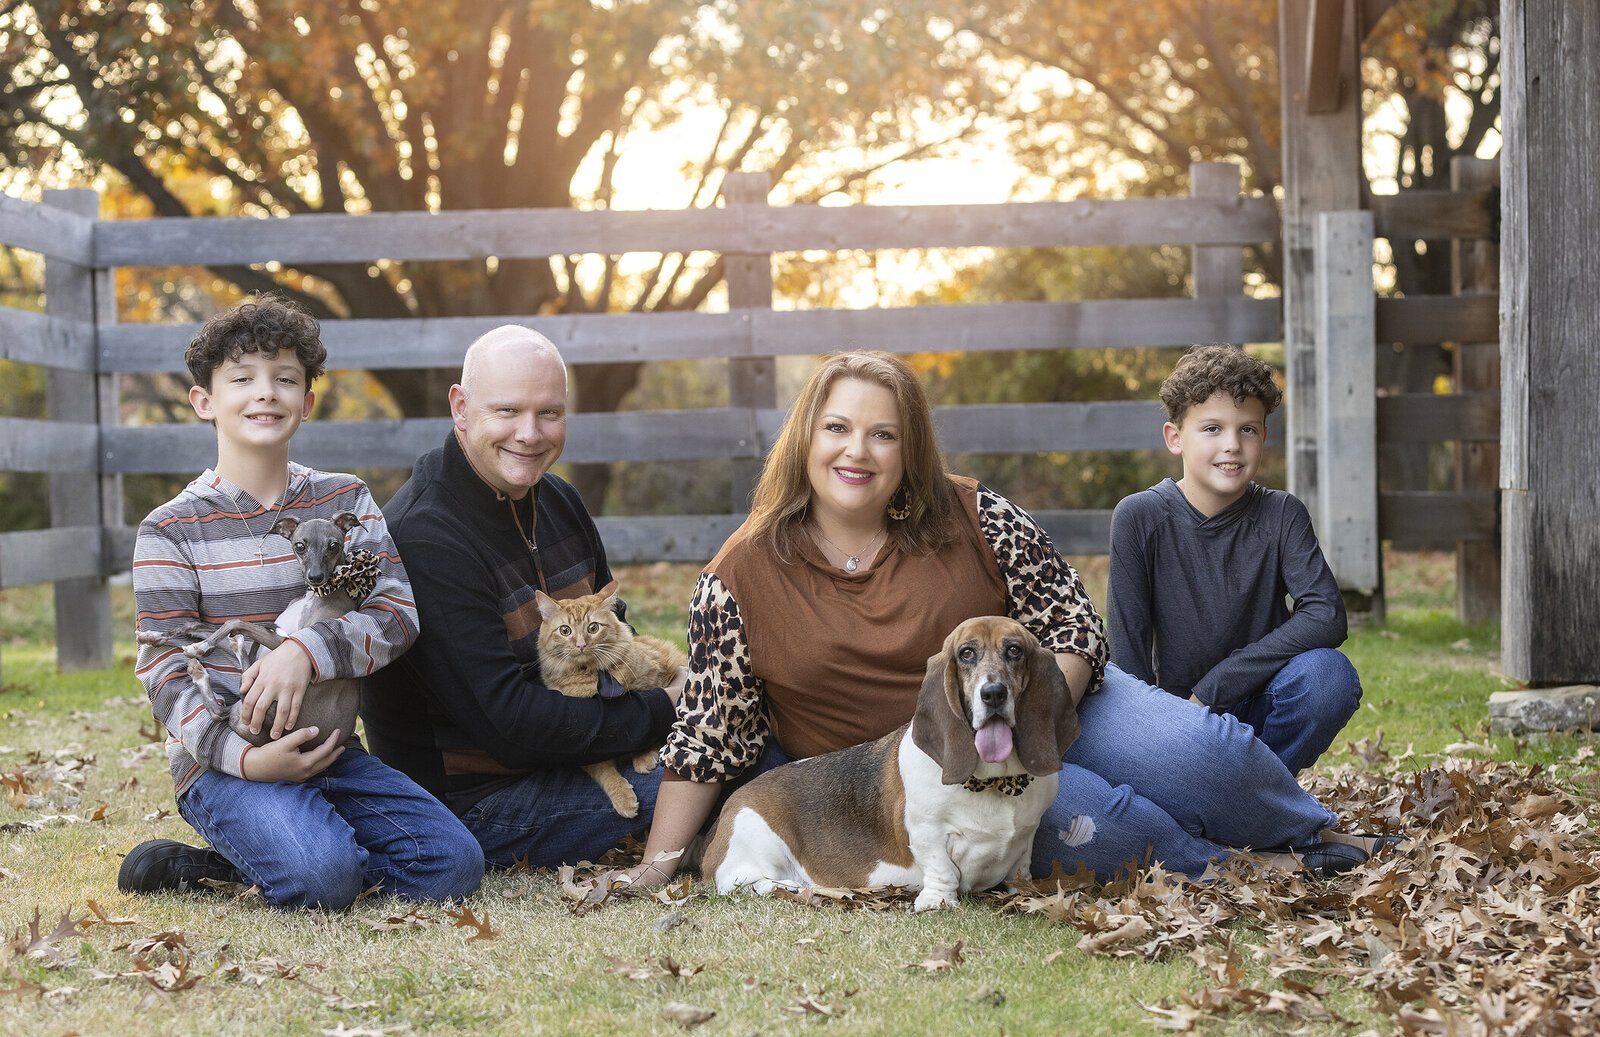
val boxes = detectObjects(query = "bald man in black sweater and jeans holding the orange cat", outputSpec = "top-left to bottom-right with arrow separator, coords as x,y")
362,325 -> 688,867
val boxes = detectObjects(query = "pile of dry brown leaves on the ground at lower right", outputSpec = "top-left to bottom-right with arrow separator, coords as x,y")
1002,746 -> 1600,1037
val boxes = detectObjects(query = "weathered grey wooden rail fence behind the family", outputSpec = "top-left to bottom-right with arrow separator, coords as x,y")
0,163 -> 1493,667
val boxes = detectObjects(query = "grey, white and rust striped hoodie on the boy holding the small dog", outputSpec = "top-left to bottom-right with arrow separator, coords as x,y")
133,462 -> 418,797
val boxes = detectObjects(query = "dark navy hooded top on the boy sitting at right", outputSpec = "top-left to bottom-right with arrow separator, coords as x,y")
1107,478 -> 1346,712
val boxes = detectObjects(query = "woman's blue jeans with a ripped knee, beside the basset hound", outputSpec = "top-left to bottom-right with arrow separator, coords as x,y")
1032,666 -> 1336,882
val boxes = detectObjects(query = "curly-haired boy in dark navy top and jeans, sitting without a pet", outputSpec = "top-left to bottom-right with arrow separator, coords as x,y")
1107,346 -> 1362,771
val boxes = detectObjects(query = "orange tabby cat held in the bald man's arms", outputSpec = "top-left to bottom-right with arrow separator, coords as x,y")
534,579 -> 688,818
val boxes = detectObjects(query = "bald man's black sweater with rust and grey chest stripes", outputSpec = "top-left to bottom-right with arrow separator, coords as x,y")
362,434 -> 674,813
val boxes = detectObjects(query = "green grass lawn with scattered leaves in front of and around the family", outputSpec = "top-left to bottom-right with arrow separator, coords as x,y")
0,559 -> 1589,1035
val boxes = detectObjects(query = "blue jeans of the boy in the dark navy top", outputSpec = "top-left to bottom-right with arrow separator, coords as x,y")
1227,648 -> 1362,775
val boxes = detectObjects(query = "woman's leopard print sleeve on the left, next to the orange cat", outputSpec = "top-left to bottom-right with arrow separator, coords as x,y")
661,573 -> 766,783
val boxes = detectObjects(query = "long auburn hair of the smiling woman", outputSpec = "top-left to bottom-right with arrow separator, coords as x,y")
746,352 -> 955,562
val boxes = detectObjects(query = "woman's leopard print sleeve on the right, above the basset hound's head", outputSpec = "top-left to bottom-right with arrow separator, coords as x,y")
978,485 -> 1107,691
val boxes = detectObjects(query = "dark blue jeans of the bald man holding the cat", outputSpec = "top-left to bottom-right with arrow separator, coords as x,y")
461,760 -> 661,867
